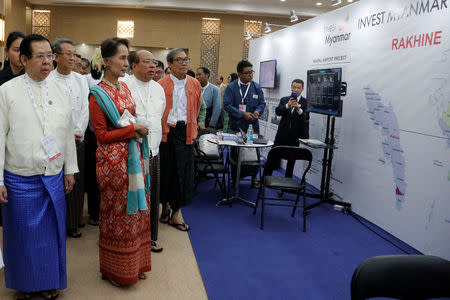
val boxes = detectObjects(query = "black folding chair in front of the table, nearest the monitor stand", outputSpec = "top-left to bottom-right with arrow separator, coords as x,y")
253,146 -> 312,232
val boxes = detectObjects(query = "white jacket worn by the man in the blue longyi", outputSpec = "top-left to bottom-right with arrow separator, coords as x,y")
0,74 -> 78,185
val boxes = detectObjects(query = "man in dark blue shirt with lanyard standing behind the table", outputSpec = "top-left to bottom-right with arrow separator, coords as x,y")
223,60 -> 266,188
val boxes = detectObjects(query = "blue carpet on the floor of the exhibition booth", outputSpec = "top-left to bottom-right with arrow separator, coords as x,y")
183,176 -> 418,300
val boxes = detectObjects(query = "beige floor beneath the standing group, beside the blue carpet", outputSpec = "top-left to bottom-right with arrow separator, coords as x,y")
0,206 -> 208,300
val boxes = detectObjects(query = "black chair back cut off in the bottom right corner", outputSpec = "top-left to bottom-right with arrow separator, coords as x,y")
351,255 -> 450,300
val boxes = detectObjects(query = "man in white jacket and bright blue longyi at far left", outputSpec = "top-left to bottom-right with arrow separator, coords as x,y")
0,34 -> 78,299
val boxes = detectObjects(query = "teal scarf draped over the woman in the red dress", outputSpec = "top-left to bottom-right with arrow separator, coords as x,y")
90,85 -> 150,215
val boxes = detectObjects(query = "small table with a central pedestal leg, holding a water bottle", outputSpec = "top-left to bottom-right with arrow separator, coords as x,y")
208,138 -> 273,207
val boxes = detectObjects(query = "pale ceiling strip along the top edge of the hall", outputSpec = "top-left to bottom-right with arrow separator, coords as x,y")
27,0 -> 357,17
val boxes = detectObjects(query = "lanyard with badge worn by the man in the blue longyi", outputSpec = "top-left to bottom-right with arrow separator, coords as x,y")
25,77 -> 61,161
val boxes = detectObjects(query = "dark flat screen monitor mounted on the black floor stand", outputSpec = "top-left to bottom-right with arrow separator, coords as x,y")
306,68 -> 342,117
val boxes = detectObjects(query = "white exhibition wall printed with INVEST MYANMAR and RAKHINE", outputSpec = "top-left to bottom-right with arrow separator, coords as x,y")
249,0 -> 450,259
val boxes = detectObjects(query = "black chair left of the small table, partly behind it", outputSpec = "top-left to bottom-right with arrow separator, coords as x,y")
194,140 -> 229,202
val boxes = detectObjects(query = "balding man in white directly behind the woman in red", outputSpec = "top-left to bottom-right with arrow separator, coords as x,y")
123,50 -> 166,252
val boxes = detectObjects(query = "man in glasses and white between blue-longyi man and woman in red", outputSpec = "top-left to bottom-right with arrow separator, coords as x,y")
49,39 -> 89,238
